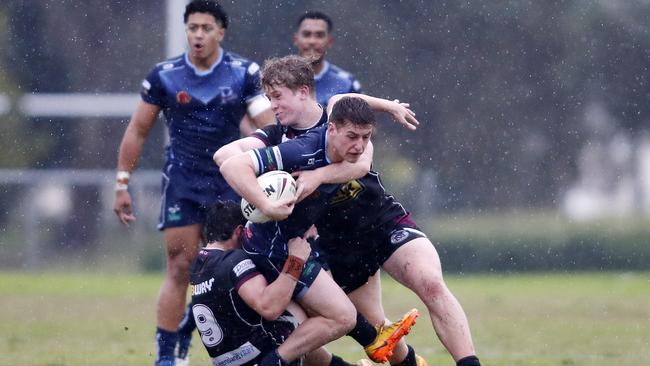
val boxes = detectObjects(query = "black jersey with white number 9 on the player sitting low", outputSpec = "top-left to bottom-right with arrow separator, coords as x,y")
190,249 -> 296,366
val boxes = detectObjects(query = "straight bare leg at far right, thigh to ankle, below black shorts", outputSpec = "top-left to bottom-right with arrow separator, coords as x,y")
383,238 -> 475,361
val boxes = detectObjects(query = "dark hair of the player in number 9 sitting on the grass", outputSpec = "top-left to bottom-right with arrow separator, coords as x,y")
203,201 -> 246,244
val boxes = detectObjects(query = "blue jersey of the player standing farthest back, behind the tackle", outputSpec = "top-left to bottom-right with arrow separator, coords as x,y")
314,61 -> 361,106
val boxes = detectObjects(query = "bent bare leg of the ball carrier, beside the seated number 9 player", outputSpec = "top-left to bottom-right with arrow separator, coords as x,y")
278,271 -> 356,361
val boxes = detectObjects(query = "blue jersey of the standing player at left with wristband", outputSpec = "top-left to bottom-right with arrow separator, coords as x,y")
140,49 -> 262,176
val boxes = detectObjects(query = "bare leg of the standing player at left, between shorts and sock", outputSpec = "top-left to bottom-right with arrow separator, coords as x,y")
157,224 -> 201,332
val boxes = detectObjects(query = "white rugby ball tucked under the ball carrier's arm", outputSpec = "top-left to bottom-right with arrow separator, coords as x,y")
241,170 -> 296,223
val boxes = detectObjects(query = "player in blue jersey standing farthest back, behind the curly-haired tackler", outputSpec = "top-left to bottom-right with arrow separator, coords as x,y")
293,11 -> 361,107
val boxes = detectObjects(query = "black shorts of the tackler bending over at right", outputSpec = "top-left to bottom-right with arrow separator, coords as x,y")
319,214 -> 426,293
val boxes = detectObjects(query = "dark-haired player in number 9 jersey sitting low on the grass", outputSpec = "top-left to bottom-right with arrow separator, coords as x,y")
190,201 -> 370,366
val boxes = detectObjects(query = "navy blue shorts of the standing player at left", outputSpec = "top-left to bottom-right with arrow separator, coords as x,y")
158,163 -> 241,230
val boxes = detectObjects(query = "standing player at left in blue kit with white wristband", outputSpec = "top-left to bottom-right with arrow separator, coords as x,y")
114,0 -> 273,362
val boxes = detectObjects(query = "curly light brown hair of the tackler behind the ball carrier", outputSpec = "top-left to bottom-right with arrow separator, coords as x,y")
261,55 -> 316,95
